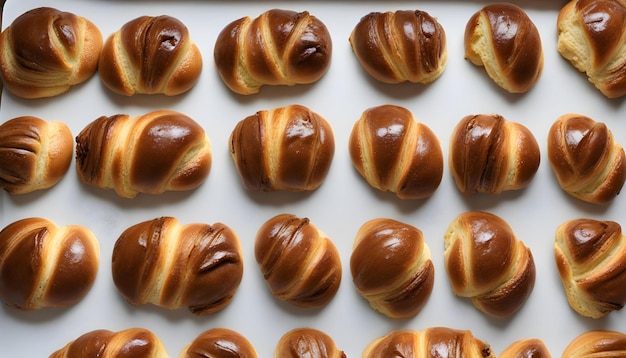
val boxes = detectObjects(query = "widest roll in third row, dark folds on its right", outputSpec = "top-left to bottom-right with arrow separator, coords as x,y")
112,217 -> 243,315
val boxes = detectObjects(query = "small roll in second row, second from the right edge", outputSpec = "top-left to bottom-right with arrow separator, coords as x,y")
448,114 -> 541,195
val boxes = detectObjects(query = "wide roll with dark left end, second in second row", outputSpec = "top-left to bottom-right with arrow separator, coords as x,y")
76,110 -> 212,198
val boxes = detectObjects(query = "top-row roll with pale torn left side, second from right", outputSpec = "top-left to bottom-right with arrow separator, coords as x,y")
464,3 -> 543,93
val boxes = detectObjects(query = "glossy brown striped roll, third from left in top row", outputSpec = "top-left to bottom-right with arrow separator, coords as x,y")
213,9 -> 332,95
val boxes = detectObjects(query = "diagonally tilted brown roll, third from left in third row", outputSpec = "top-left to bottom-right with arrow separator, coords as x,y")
254,214 -> 342,307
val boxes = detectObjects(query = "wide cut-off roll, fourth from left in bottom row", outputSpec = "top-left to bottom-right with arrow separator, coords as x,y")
362,327 -> 495,358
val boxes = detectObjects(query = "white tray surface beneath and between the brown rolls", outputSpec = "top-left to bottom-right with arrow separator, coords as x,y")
0,0 -> 626,357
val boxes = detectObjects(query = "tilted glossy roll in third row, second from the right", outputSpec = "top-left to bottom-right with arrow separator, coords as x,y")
444,211 -> 536,317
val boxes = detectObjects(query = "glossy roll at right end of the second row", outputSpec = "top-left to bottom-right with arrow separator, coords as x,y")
548,113 -> 626,204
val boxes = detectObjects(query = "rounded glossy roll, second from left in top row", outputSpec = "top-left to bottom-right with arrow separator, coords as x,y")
98,15 -> 202,96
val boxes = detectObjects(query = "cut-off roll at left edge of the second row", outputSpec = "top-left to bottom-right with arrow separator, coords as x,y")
0,116 -> 74,194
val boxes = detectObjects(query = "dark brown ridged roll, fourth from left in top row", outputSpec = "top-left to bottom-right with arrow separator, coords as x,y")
350,10 -> 448,83
